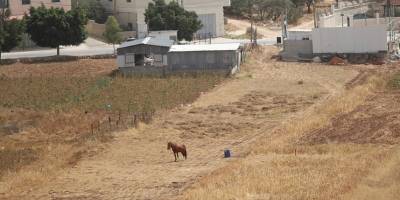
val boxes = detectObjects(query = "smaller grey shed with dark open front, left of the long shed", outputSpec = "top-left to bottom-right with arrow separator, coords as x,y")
117,37 -> 174,68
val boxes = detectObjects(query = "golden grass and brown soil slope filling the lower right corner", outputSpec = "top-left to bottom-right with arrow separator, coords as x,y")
182,69 -> 400,200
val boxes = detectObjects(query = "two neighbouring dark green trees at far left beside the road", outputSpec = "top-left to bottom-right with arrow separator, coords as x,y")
0,5 -> 87,59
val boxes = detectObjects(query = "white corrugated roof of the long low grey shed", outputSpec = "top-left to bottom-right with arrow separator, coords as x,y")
169,43 -> 240,52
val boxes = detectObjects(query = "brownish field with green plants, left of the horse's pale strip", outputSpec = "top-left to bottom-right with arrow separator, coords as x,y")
0,59 -> 223,196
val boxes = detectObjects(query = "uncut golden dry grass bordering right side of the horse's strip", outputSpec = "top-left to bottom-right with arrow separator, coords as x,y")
183,72 -> 392,199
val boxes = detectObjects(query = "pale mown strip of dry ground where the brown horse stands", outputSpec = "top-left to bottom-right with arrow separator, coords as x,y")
5,49 -> 357,199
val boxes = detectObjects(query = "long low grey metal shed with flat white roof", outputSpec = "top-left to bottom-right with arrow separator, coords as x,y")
168,43 -> 242,74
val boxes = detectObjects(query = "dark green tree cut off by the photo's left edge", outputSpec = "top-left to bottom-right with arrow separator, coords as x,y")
0,8 -> 25,60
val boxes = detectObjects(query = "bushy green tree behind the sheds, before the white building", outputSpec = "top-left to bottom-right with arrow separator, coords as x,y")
144,0 -> 202,41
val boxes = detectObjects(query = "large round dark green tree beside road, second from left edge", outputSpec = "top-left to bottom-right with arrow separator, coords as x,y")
25,5 -> 87,55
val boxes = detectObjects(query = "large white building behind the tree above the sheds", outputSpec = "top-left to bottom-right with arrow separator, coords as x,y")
101,0 -> 230,37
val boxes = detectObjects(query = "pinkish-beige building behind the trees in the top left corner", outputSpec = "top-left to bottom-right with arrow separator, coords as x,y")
0,0 -> 71,17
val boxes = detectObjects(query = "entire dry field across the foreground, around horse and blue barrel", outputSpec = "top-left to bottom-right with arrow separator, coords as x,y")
0,47 -> 400,200
